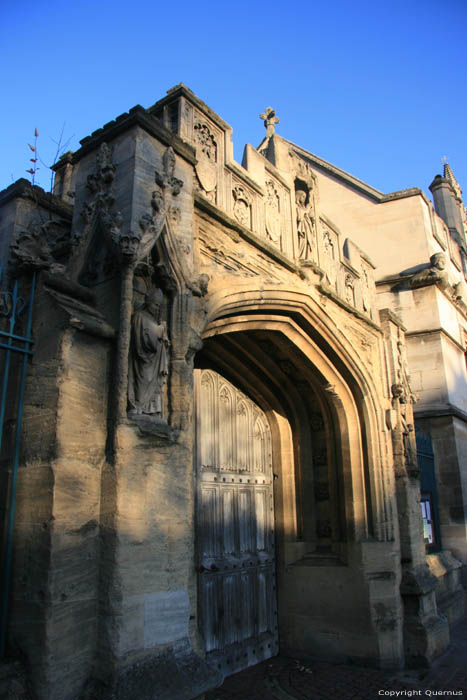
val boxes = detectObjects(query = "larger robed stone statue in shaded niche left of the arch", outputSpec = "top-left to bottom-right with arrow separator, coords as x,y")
128,289 -> 169,419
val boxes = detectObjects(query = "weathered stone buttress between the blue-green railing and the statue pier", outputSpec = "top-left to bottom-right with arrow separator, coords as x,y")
11,280 -> 109,698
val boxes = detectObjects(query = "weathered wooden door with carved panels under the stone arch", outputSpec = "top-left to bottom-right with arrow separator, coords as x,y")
195,370 -> 278,673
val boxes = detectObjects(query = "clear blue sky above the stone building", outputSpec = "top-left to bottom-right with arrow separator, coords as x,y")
0,0 -> 467,201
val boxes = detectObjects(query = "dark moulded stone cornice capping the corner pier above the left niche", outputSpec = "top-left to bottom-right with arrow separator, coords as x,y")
72,105 -> 196,165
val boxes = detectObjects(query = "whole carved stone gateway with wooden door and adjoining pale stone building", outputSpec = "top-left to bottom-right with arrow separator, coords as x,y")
0,85 -> 467,700
